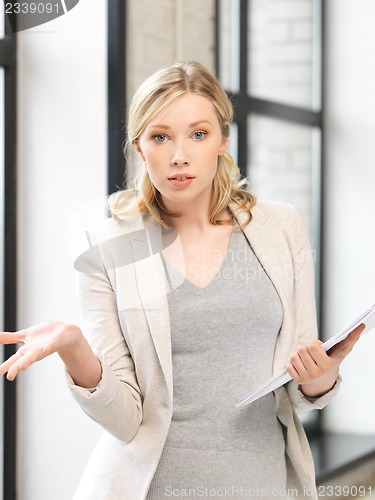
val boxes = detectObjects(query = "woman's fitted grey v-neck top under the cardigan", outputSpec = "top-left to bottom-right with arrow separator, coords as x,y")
147,228 -> 286,500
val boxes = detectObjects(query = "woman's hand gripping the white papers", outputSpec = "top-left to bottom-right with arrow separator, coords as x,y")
285,324 -> 365,398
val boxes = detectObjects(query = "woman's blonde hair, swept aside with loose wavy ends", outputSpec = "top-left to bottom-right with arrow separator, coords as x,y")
109,62 -> 255,227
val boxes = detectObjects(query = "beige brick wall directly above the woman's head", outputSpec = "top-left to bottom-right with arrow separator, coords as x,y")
126,0 -> 214,100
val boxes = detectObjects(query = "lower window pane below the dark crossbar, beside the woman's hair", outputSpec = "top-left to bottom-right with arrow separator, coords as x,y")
248,114 -> 319,232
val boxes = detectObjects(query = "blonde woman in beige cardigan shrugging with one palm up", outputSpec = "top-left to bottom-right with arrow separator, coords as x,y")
0,63 -> 362,500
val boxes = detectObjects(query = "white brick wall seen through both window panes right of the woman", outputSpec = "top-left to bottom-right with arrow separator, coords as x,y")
248,0 -> 319,229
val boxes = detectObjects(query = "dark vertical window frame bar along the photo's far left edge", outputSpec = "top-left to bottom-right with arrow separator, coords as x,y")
0,9 -> 17,500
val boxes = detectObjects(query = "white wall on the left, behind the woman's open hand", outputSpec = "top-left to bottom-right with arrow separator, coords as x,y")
18,0 -> 107,500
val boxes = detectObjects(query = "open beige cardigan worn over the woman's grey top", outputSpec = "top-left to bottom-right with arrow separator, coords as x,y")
68,201 -> 338,500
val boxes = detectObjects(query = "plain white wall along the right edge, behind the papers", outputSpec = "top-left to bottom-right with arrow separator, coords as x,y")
325,0 -> 375,433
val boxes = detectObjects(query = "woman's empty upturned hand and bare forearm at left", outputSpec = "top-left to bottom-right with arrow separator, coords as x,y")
0,321 -> 101,387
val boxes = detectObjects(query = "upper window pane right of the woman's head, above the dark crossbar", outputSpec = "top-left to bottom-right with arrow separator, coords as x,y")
248,0 -> 321,110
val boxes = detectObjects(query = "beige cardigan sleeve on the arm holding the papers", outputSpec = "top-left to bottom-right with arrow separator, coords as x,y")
287,206 -> 341,413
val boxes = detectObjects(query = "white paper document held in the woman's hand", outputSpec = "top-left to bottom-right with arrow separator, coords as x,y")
236,304 -> 375,407
